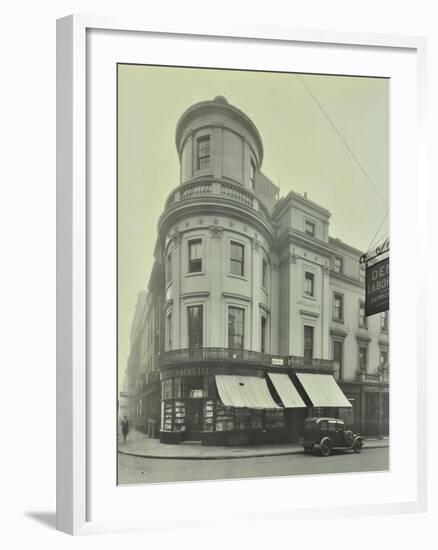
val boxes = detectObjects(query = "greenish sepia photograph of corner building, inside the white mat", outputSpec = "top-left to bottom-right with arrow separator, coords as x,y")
115,64 -> 390,485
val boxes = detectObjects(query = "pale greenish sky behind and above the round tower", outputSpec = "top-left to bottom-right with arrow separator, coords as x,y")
118,65 -> 389,382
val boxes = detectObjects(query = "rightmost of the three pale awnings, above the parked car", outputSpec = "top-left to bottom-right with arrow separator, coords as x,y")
297,372 -> 351,407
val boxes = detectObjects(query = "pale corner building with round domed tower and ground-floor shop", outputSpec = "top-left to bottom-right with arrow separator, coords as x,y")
129,96 -> 389,445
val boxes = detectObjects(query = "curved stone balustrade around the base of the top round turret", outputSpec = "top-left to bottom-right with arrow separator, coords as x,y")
166,179 -> 269,219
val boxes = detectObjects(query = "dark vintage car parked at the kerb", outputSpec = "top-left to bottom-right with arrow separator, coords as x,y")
302,417 -> 363,456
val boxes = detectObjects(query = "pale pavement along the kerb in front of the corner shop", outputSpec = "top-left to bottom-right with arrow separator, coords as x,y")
118,430 -> 389,460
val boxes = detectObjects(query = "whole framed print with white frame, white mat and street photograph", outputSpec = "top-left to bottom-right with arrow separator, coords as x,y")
57,16 -> 426,534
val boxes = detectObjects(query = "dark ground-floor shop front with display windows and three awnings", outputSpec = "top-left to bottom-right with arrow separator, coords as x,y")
160,367 -> 351,445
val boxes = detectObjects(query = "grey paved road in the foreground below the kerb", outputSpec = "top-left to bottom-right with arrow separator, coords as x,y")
119,447 -> 389,484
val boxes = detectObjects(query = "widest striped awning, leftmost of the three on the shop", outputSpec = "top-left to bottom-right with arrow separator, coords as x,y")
215,374 -> 281,409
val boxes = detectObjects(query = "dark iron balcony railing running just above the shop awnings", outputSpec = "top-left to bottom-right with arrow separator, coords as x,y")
161,348 -> 333,372
